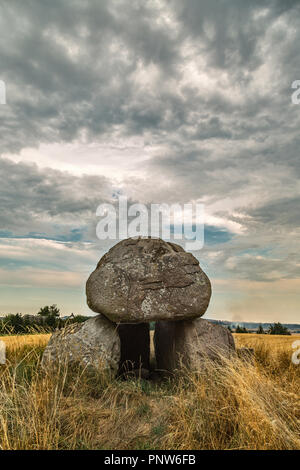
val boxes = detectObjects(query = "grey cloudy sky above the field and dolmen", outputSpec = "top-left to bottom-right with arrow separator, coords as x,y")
0,0 -> 300,322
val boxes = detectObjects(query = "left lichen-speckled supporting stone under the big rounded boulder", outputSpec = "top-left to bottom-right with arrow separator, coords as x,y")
42,315 -> 121,375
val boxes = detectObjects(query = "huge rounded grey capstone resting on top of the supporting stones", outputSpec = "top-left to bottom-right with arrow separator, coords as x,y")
86,237 -> 211,323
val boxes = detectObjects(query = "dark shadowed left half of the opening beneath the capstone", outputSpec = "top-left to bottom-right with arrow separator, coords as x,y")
118,323 -> 150,375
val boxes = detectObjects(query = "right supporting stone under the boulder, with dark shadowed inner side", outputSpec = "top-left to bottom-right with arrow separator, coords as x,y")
154,318 -> 235,372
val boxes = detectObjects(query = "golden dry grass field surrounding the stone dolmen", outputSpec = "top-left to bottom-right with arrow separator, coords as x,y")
0,328 -> 300,449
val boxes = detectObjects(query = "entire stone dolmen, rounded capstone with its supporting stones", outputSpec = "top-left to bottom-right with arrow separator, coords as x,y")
42,237 -> 235,378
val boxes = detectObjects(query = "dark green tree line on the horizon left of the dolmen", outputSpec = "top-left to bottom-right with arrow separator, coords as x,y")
0,304 -> 89,335
